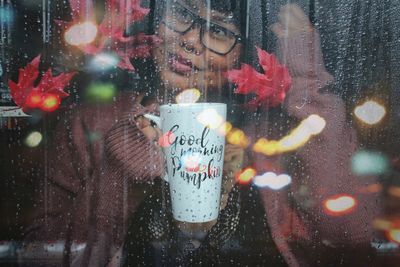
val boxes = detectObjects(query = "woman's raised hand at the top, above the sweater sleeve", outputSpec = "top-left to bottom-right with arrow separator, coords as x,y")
272,4 -> 313,38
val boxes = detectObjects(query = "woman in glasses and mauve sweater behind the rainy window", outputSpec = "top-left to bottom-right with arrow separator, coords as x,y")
28,0 -> 377,266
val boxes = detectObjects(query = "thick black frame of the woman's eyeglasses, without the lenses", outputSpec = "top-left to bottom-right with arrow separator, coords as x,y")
161,3 -> 243,56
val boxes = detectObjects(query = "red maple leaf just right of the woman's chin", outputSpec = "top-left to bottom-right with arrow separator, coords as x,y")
227,47 -> 292,107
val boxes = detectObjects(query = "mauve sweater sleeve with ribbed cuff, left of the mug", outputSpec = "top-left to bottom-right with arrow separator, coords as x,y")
26,99 -> 163,266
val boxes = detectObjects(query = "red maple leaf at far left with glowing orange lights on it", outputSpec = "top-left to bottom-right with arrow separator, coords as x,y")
8,55 -> 75,113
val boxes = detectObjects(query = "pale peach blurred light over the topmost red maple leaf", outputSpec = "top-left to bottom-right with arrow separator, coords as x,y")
64,21 -> 97,46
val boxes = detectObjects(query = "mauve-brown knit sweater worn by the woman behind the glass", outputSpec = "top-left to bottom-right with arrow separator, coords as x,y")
27,30 -> 379,266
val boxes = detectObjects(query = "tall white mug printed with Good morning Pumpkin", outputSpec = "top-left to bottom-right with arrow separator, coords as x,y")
144,103 -> 226,223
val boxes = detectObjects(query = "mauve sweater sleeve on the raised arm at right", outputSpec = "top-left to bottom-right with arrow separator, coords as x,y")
263,31 -> 380,251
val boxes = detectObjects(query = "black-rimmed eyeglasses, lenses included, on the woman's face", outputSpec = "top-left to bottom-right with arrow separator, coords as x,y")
162,3 -> 242,55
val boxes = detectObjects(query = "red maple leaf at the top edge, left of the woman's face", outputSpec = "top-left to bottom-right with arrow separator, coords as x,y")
57,0 -> 161,71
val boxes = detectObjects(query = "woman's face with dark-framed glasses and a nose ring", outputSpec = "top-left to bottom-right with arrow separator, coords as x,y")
153,0 -> 242,96
